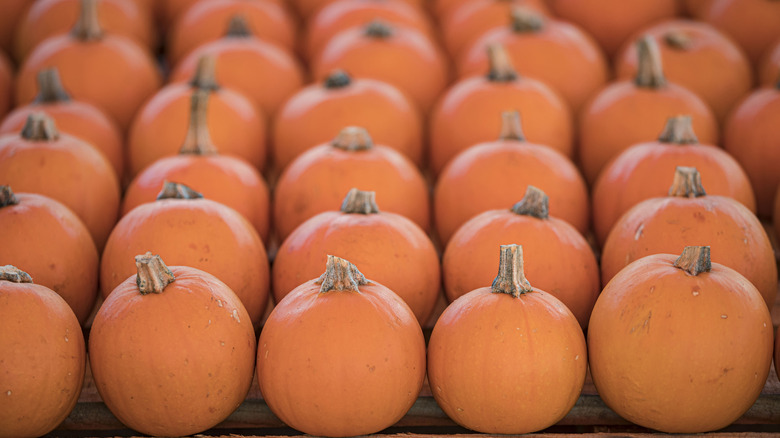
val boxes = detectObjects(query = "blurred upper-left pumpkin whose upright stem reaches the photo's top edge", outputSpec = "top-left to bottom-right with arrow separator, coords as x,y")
16,0 -> 161,130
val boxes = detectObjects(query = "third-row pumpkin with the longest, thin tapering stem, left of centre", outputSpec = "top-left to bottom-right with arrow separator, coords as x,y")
122,90 -> 271,242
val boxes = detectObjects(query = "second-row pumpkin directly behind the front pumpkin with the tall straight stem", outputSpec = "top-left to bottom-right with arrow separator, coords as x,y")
442,185 -> 601,329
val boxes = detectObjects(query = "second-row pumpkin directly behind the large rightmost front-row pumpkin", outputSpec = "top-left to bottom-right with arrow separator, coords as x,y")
601,167 -> 777,309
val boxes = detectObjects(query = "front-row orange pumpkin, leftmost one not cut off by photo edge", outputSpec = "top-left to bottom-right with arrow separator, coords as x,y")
89,253 -> 256,436
